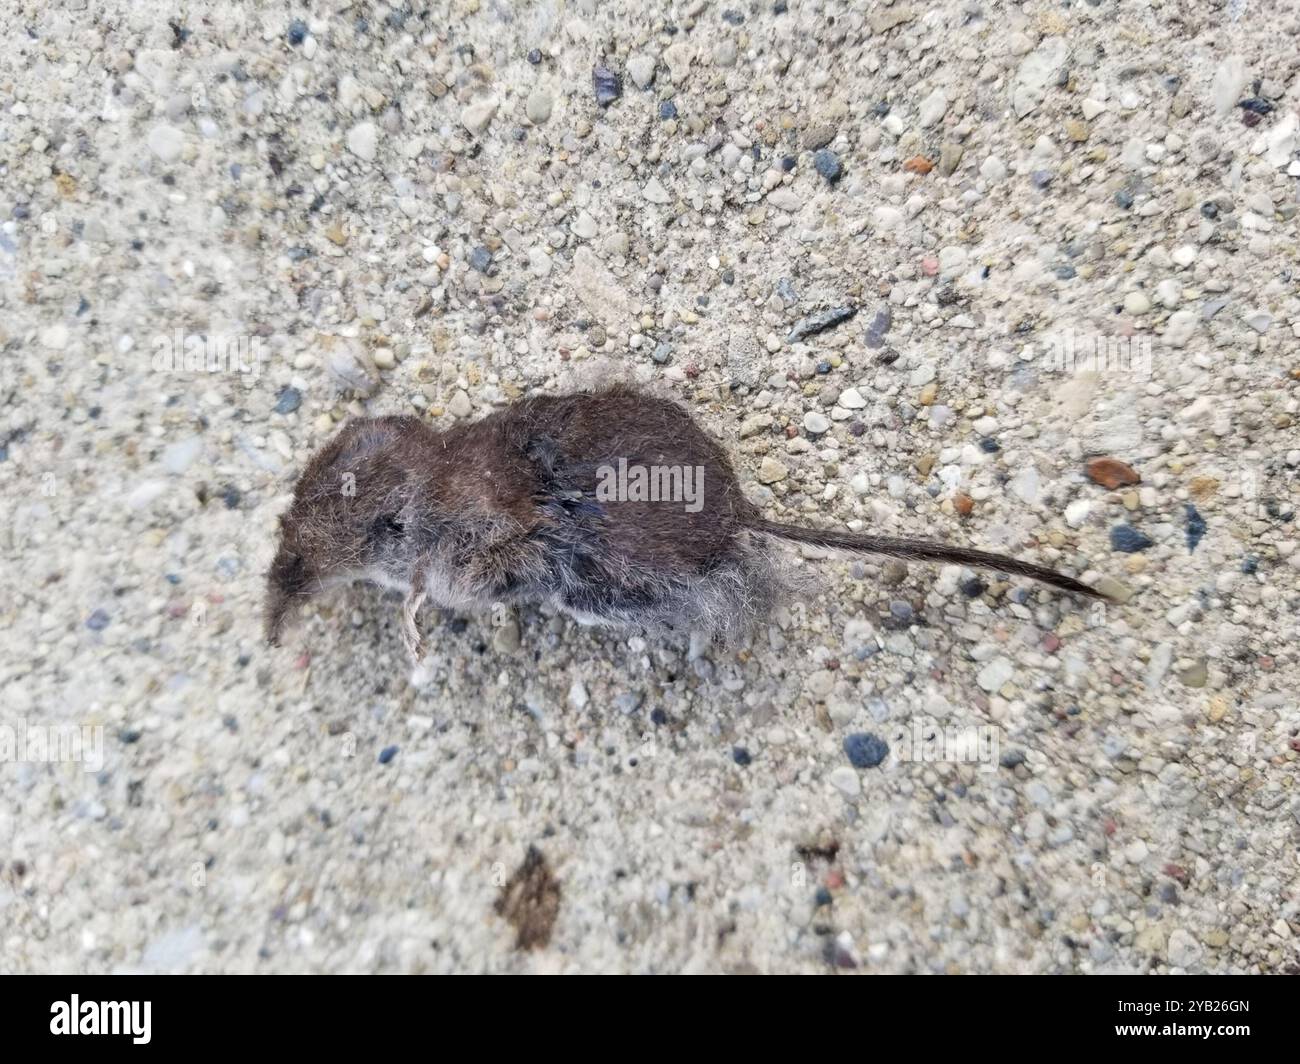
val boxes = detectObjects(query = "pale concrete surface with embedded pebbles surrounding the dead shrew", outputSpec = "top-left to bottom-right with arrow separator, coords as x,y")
0,0 -> 1300,972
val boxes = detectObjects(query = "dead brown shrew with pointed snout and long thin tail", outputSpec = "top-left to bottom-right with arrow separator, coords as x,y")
267,386 -> 1095,656
